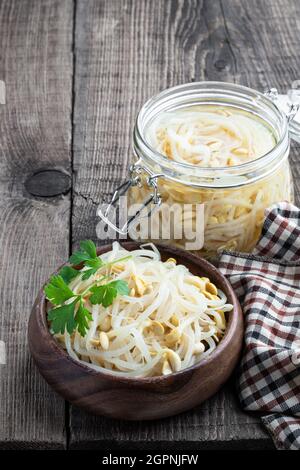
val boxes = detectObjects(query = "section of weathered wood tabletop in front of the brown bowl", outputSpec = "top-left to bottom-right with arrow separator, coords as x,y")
70,386 -> 273,451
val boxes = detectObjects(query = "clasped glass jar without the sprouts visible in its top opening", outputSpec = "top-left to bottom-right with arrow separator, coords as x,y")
104,82 -> 299,257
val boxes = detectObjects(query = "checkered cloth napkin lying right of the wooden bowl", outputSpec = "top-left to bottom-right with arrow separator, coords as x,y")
220,202 -> 300,450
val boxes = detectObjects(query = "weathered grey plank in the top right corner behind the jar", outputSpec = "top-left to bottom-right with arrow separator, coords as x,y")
220,0 -> 300,204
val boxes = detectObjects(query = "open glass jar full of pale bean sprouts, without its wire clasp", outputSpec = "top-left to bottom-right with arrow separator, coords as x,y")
125,82 -> 293,258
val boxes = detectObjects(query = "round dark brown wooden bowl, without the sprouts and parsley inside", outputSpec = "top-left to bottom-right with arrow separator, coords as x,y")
28,242 -> 243,420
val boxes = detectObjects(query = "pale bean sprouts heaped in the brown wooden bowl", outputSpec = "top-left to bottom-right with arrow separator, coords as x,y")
50,242 -> 233,377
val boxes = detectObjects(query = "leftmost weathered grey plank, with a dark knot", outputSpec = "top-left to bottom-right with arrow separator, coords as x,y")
0,0 -> 73,448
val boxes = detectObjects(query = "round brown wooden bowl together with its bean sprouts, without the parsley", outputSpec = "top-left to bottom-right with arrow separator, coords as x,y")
28,242 -> 243,420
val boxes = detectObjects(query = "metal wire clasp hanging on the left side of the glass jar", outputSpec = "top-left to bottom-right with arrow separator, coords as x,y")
98,160 -> 164,235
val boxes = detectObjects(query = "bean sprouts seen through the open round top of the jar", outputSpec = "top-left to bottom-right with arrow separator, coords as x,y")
146,106 -> 276,167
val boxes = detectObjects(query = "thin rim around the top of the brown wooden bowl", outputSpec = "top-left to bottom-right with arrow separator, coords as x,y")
38,242 -> 240,385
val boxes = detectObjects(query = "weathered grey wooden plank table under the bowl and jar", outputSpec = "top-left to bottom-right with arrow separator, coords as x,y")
0,0 -> 300,450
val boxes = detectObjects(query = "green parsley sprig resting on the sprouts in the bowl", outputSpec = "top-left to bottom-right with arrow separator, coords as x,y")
44,240 -> 131,336
